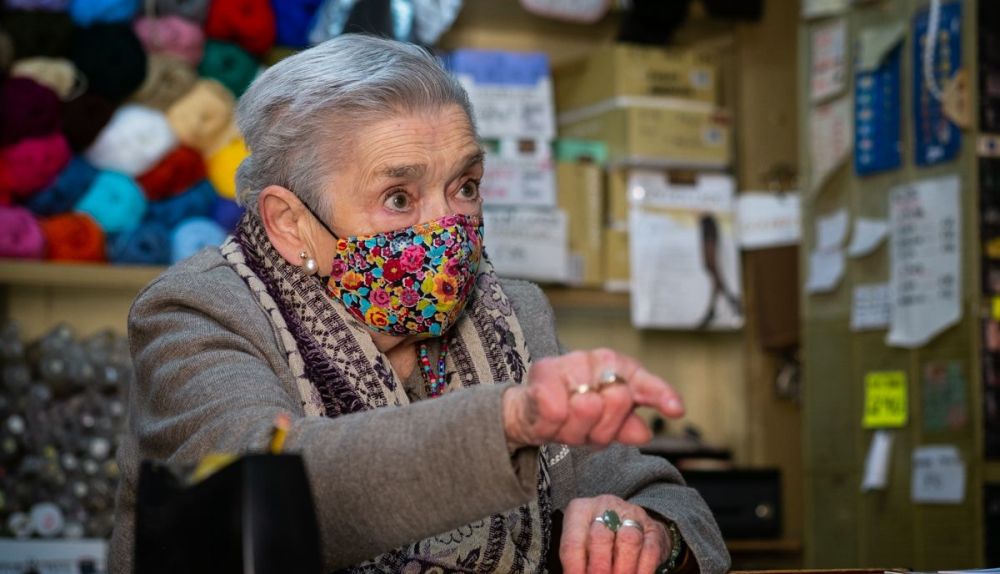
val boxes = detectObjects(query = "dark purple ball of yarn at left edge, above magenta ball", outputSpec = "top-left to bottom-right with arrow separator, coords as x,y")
0,78 -> 61,145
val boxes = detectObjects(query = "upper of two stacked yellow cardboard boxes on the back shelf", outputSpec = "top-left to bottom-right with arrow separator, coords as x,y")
555,44 -> 718,113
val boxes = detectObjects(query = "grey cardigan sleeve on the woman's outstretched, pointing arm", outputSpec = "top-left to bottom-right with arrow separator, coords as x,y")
112,267 -> 538,572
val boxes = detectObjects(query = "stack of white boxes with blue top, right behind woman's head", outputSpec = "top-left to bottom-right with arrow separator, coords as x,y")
445,50 -> 569,282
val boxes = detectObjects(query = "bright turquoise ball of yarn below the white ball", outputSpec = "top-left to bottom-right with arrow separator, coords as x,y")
76,171 -> 146,233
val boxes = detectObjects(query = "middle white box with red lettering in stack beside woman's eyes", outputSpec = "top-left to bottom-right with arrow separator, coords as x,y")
480,138 -> 557,207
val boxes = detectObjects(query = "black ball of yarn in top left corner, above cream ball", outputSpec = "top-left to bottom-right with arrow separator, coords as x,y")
0,10 -> 74,59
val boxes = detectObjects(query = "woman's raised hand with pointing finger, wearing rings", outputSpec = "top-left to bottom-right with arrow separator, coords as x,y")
503,349 -> 684,452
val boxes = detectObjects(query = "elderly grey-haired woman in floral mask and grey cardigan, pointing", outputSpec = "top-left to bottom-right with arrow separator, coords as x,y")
111,36 -> 729,573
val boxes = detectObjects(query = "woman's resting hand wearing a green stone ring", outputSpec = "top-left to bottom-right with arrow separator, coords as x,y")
559,495 -> 671,574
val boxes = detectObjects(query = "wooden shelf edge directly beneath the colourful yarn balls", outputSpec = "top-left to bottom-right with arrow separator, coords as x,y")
0,259 -> 166,291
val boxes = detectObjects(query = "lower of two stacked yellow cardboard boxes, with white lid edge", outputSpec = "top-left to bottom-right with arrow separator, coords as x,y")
559,96 -> 732,169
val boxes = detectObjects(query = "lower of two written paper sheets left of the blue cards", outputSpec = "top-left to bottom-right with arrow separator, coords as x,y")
809,96 -> 854,193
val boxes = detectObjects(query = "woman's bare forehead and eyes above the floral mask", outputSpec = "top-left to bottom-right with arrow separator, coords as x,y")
327,106 -> 483,237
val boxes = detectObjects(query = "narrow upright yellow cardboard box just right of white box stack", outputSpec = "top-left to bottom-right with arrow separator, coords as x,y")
556,162 -> 604,287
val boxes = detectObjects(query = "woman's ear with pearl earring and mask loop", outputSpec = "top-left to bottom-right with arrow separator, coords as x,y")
257,185 -> 316,272
